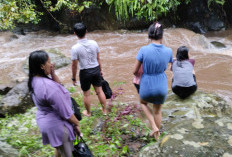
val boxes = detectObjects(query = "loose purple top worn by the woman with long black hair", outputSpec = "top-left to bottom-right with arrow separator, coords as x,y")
32,77 -> 75,147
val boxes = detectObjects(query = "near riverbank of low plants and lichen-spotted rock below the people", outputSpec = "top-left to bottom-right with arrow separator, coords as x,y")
0,91 -> 232,157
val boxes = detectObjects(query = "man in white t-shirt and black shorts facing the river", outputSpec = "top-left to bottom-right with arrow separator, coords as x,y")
71,23 -> 106,116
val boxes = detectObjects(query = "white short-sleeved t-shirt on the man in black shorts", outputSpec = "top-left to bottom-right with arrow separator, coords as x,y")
71,38 -> 99,70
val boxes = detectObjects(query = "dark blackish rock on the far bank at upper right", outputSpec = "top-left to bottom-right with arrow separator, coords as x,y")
177,0 -> 226,33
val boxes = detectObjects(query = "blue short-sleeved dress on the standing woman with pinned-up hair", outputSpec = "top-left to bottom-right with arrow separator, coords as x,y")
137,43 -> 172,104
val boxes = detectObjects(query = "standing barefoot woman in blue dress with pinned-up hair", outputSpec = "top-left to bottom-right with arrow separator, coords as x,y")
134,22 -> 172,139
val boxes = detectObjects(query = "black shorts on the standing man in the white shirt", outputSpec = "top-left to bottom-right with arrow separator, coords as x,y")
79,66 -> 101,91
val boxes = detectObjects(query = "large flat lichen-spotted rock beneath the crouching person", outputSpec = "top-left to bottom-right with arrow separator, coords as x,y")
139,92 -> 232,157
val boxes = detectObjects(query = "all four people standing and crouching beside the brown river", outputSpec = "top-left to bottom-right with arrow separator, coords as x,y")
28,22 -> 197,157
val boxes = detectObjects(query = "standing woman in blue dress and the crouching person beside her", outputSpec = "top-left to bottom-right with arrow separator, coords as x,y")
133,22 -> 197,139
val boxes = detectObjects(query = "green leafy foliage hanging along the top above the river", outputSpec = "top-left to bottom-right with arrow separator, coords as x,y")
0,0 -> 225,30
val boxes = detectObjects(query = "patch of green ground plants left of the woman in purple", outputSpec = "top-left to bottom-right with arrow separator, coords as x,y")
0,108 -> 54,157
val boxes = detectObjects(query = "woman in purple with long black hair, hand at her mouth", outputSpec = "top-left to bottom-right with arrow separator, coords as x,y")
28,51 -> 80,157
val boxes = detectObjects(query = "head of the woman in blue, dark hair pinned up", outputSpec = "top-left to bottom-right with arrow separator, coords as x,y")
148,22 -> 163,40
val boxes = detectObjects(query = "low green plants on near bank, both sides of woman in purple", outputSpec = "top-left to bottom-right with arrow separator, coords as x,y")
0,87 -> 158,157
